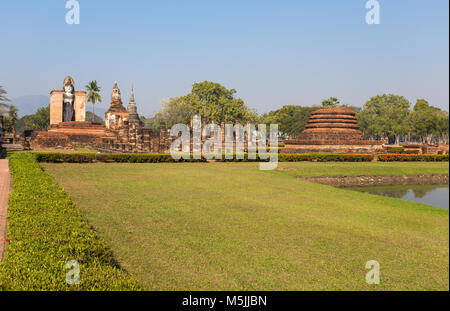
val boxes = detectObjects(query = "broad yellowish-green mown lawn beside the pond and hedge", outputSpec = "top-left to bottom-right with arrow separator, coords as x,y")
42,163 -> 449,290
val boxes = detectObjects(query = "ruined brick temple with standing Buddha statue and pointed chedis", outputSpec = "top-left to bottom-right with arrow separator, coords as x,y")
31,77 -> 170,153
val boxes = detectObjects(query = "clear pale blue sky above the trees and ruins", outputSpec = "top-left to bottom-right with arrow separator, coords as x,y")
0,0 -> 449,116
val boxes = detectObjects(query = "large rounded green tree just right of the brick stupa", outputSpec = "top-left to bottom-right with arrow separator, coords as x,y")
358,94 -> 411,144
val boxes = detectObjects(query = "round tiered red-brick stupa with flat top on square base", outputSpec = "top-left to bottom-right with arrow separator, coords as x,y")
283,107 -> 383,153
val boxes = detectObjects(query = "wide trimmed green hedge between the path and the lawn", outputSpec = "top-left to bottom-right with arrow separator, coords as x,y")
0,153 -> 141,291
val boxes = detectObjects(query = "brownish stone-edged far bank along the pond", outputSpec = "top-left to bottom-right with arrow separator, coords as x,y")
297,174 -> 449,188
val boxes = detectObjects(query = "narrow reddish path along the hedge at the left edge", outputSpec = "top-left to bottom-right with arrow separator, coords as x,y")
0,160 -> 11,261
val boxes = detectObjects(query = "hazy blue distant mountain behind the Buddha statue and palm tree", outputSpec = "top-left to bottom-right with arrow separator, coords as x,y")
10,95 -> 106,118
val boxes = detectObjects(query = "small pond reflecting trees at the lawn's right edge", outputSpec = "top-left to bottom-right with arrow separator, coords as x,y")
350,185 -> 449,209
